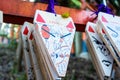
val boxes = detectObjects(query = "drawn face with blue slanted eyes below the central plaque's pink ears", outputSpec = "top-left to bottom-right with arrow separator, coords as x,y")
38,24 -> 74,76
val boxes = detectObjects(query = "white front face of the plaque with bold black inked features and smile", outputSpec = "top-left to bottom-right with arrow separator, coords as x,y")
86,22 -> 113,77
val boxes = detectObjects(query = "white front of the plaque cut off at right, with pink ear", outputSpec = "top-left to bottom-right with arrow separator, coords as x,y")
98,12 -> 120,56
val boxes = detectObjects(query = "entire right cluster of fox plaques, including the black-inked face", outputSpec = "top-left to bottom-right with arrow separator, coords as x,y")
85,12 -> 120,80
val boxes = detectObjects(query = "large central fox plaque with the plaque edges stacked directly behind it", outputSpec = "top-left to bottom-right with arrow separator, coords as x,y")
33,10 -> 75,80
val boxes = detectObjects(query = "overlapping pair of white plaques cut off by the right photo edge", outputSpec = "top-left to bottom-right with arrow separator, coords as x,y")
97,13 -> 120,67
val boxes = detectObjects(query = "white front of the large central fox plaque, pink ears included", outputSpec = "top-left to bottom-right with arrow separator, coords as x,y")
34,10 -> 75,76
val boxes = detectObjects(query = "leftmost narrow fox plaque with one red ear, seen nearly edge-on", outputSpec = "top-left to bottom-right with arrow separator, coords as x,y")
20,23 -> 34,80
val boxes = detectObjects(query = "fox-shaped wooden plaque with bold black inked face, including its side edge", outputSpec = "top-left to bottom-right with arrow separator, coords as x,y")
86,22 -> 113,80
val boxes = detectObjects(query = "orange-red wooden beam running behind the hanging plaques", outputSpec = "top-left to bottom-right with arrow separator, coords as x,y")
0,0 -> 94,31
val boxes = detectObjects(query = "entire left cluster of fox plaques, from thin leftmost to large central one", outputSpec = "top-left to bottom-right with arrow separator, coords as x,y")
21,10 -> 75,80
